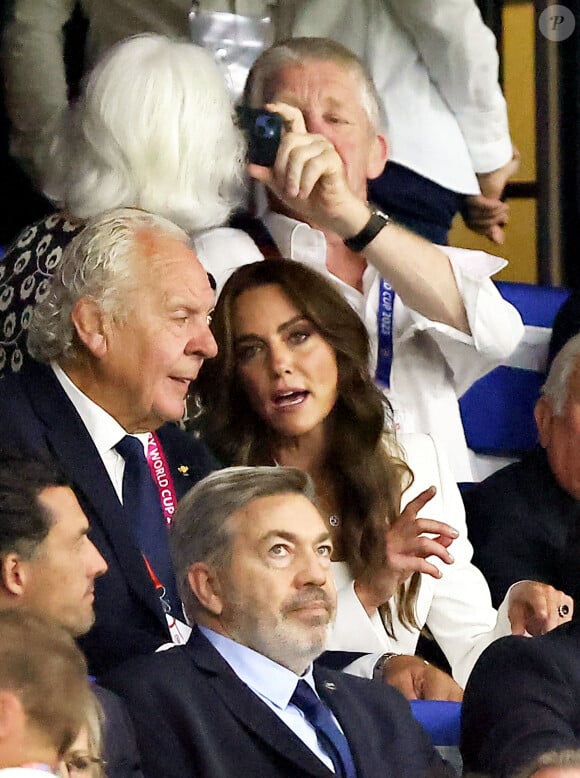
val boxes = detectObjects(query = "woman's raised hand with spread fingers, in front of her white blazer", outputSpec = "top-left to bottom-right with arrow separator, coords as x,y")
355,486 -> 459,615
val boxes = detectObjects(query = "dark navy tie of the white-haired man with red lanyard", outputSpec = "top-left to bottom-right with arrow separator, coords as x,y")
115,435 -> 183,618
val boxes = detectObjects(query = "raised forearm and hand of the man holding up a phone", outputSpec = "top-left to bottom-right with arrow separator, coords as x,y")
248,103 -> 469,334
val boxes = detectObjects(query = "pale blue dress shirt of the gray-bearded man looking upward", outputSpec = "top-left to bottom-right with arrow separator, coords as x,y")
199,626 -> 342,772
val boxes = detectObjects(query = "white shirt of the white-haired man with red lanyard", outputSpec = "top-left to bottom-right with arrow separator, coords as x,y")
51,362 -> 149,504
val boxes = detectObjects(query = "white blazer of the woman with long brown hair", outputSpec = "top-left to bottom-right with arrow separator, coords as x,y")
328,435 -> 511,687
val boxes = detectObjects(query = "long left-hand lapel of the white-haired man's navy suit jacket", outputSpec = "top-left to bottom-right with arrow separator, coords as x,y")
26,365 -> 165,624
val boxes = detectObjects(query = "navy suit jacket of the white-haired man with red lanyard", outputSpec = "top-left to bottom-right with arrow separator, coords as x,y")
0,362 -> 217,676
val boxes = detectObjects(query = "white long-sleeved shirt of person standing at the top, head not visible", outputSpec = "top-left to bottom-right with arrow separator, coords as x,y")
279,0 -> 512,194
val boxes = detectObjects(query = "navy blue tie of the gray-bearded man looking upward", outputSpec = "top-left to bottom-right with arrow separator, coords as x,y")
290,680 -> 356,778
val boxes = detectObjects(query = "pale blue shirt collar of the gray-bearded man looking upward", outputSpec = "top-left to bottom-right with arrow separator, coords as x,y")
199,627 -> 316,710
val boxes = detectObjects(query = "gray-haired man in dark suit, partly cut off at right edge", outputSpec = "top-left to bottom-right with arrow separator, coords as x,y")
463,335 -> 580,615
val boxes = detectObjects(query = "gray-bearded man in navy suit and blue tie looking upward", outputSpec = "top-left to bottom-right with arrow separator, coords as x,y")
105,467 -> 453,778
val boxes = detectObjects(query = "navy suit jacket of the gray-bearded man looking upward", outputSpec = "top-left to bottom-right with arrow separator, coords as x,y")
103,628 -> 455,778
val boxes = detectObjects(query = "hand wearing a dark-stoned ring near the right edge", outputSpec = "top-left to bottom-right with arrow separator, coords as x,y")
508,581 -> 574,635
